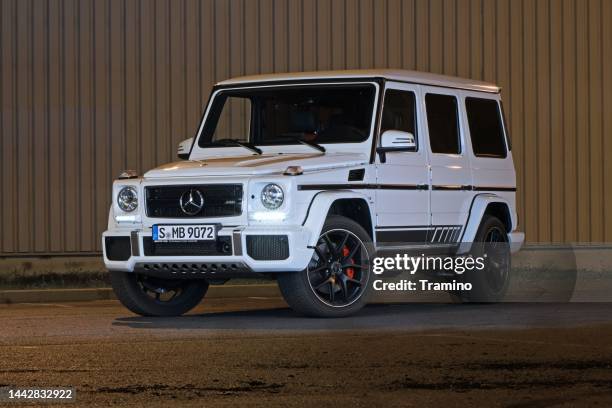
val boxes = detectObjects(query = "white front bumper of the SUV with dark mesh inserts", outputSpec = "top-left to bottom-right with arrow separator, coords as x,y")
102,226 -> 313,277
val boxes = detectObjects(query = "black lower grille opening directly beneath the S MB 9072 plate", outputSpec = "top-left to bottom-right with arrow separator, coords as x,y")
142,236 -> 232,256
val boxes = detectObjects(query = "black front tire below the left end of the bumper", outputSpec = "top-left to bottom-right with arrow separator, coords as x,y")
111,272 -> 208,316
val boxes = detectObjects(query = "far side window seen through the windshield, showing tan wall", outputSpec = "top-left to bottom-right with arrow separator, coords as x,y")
212,96 -> 251,142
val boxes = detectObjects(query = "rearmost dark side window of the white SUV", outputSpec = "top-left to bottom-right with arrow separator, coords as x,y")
465,98 -> 506,159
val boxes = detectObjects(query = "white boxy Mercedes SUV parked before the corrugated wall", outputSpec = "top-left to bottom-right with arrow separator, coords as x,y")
102,70 -> 524,316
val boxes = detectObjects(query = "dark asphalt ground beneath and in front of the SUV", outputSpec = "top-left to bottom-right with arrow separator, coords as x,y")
0,298 -> 612,407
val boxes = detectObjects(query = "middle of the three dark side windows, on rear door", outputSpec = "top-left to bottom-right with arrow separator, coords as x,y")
425,94 -> 461,154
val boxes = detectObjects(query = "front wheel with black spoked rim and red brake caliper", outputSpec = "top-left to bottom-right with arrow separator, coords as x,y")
278,216 -> 373,317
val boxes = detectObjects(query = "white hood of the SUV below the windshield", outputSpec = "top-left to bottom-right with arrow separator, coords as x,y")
144,153 -> 368,178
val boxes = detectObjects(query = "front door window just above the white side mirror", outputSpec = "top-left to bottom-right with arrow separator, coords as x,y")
380,89 -> 418,146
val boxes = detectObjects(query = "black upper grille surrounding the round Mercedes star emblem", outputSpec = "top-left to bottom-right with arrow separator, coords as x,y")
145,184 -> 242,218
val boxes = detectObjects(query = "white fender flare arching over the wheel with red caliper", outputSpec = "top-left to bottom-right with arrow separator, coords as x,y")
302,190 -> 375,246
